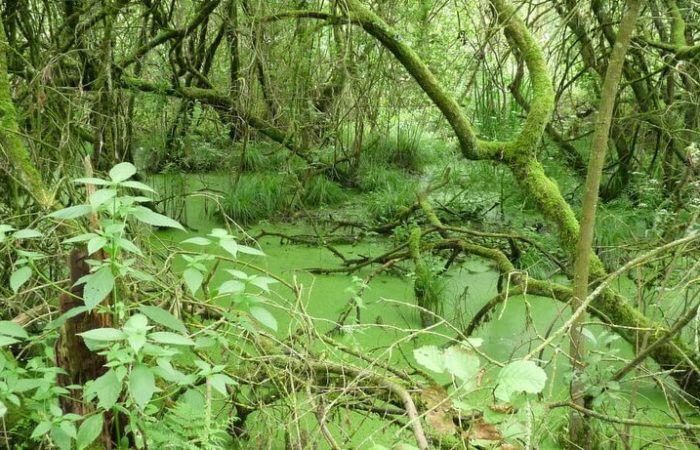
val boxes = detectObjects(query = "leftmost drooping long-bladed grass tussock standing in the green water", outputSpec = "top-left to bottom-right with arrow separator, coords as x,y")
222,173 -> 294,224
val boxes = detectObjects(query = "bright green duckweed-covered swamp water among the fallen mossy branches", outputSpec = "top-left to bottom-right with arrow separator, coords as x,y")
148,174 -> 694,450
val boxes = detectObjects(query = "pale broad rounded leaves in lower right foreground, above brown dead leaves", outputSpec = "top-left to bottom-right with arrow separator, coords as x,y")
413,338 -> 547,446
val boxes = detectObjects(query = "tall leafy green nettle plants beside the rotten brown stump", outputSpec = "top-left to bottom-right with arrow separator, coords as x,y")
0,163 -> 277,450
